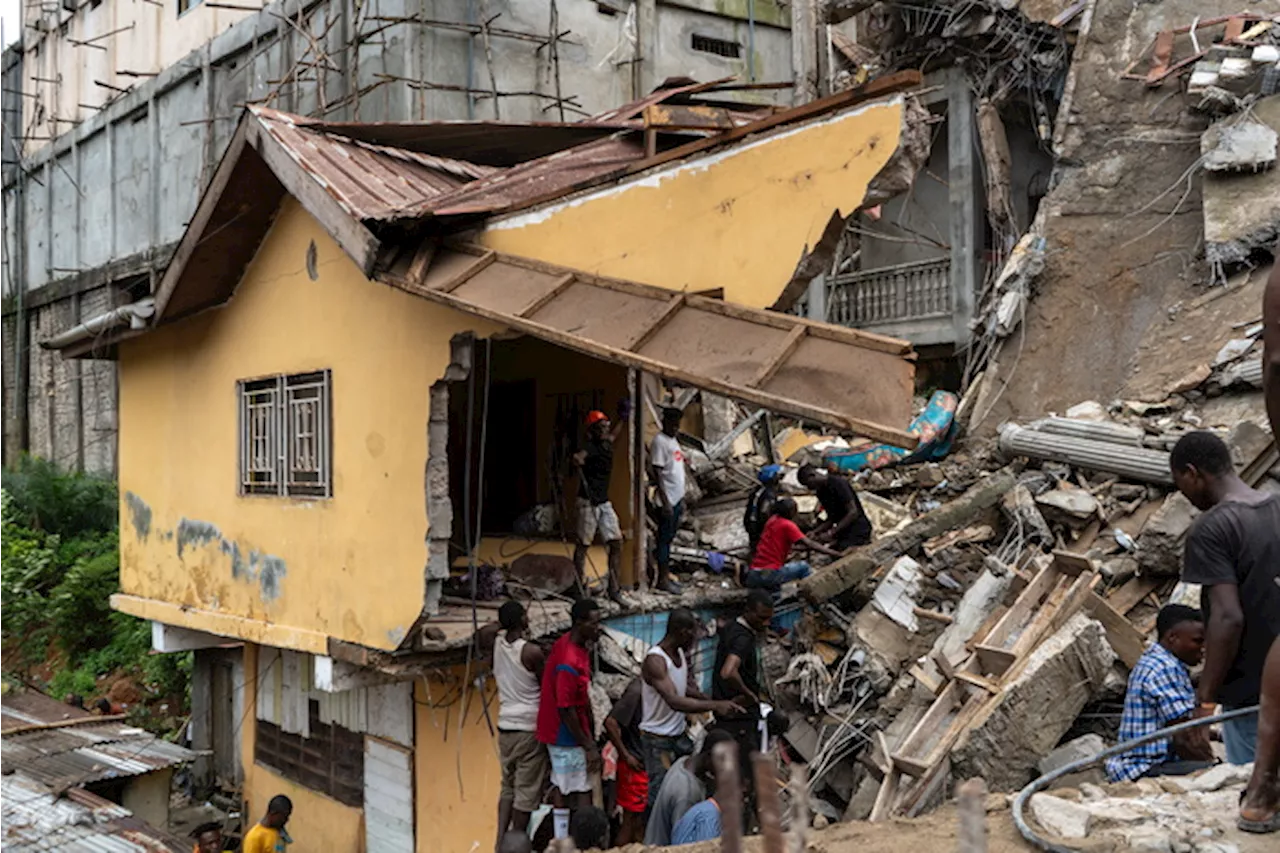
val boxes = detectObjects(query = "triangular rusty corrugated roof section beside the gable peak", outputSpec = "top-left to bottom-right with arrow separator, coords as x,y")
250,106 -> 495,220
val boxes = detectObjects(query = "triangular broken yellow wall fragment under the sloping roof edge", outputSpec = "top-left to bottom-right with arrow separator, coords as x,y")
480,97 -> 902,307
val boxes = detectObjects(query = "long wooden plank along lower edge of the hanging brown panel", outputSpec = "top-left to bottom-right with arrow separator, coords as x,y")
379,267 -> 919,448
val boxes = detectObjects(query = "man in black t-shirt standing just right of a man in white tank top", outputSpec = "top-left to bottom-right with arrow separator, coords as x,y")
712,589 -> 773,780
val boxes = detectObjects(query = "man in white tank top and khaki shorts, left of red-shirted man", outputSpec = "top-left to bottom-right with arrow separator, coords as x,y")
493,601 -> 549,845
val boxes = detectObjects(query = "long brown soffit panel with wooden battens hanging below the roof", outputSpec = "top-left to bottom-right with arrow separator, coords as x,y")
381,243 -> 916,448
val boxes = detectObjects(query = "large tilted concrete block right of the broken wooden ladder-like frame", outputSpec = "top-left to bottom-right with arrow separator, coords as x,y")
951,613 -> 1116,792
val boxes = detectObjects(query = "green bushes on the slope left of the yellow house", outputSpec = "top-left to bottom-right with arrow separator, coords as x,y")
0,459 -> 191,713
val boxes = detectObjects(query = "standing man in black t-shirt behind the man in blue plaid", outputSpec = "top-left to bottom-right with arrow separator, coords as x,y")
1169,432 -> 1280,765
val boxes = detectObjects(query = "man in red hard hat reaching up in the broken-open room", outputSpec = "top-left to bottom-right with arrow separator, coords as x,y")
573,401 -> 628,601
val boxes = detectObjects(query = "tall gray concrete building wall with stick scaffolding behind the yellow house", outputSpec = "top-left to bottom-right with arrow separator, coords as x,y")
0,0 -> 791,473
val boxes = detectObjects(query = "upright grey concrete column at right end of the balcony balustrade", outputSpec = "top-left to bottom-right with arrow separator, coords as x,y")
947,68 -> 982,348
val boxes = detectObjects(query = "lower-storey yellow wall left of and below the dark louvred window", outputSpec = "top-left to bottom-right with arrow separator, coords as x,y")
241,643 -> 365,853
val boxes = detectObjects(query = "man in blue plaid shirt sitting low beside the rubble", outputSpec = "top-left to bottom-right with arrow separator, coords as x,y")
1107,605 -> 1215,781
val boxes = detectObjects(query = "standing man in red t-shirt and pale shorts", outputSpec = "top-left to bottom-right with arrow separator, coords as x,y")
538,598 -> 600,838
